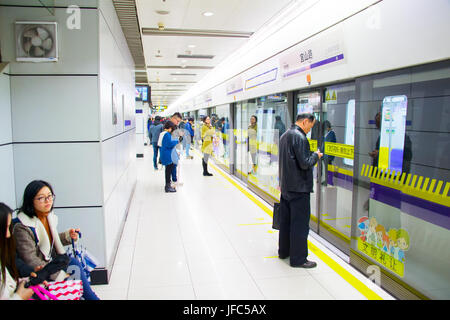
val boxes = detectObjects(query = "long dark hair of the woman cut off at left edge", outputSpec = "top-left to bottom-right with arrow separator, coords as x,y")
0,202 -> 19,287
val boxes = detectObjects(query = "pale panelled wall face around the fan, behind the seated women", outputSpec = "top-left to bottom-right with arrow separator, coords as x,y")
0,1 -> 106,266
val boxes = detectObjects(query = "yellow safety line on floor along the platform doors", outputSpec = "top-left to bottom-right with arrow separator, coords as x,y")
207,164 -> 383,300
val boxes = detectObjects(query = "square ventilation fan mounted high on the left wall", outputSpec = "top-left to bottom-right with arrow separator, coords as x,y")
15,21 -> 58,62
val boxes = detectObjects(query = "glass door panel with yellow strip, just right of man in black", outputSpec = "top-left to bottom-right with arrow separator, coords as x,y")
319,83 -> 355,255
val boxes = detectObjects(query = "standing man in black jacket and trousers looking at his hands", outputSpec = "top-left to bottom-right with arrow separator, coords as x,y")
278,113 -> 323,268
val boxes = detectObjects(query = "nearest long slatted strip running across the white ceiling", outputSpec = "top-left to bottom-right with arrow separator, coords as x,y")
142,28 -> 253,39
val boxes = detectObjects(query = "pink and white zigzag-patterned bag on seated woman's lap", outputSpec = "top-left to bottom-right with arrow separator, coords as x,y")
30,280 -> 83,300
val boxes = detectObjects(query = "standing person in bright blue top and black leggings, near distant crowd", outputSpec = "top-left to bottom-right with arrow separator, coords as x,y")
158,121 -> 183,192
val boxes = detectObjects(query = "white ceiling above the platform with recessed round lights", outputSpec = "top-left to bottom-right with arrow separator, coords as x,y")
136,0 -> 293,105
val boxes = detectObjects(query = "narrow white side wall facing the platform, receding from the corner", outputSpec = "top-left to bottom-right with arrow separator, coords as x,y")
98,0 -> 137,266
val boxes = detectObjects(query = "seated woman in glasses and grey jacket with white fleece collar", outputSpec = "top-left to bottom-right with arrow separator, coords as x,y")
13,180 -> 99,300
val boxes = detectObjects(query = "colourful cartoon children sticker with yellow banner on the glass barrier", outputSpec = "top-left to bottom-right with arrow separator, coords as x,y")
358,216 -> 411,277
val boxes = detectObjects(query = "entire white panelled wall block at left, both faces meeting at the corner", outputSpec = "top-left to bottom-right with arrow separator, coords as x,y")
0,0 -> 136,276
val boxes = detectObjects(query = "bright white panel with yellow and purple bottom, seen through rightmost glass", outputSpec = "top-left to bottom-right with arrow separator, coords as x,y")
378,95 -> 408,172
